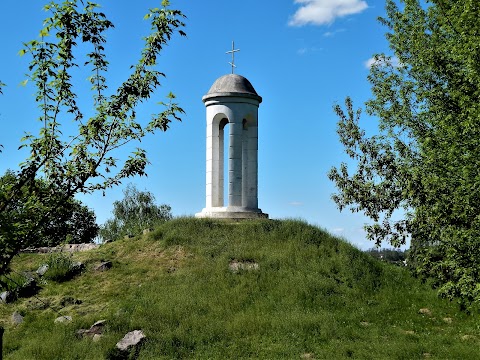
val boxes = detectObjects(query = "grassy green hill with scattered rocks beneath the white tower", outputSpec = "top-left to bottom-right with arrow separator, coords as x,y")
0,218 -> 480,360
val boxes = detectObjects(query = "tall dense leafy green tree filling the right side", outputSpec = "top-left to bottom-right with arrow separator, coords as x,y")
329,0 -> 480,307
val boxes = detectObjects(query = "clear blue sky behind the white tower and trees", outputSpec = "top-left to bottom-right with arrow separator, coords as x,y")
0,0 -> 398,249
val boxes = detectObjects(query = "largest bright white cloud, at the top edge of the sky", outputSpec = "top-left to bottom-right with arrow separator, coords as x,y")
288,0 -> 368,26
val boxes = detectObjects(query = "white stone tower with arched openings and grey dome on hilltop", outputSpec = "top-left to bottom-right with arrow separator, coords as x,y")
195,73 -> 268,219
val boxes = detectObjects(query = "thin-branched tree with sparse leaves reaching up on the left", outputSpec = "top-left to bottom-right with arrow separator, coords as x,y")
0,0 -> 185,274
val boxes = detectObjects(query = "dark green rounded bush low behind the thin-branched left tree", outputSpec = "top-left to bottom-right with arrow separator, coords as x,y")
0,170 -> 99,247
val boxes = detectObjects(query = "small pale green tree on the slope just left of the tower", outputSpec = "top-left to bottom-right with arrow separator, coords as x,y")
100,184 -> 172,241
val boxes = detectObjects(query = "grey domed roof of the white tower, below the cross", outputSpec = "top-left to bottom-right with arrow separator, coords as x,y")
203,74 -> 262,101
